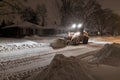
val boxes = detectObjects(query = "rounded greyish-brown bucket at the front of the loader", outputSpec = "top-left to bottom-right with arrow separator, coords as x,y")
50,39 -> 67,49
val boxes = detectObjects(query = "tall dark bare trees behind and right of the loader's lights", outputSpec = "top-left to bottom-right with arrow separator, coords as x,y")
60,0 -> 120,36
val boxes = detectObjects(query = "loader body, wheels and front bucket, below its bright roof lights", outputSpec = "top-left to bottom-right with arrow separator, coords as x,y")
50,32 -> 89,49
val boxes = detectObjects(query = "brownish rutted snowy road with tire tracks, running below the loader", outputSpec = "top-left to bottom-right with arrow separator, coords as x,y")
0,45 -> 99,80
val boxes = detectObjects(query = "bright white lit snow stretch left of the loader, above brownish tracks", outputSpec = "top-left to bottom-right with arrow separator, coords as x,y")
0,38 -> 52,62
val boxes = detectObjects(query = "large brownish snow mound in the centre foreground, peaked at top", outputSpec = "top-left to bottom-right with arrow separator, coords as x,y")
27,54 -> 94,80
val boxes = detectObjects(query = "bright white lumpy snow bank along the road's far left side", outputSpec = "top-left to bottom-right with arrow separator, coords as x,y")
0,41 -> 44,52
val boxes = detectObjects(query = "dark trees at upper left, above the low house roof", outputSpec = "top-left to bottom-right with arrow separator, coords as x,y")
0,0 -> 47,26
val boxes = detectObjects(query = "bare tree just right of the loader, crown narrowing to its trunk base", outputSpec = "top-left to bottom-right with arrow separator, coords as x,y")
92,6 -> 114,36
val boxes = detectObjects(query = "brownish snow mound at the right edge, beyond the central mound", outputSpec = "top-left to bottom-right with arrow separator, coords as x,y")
93,43 -> 120,66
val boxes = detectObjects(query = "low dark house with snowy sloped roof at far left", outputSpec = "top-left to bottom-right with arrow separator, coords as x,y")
1,22 -> 40,37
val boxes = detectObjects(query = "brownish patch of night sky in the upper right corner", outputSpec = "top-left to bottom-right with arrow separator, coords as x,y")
99,0 -> 120,15
